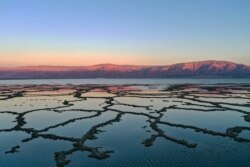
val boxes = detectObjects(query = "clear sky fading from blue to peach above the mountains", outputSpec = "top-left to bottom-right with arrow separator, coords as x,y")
0,0 -> 250,66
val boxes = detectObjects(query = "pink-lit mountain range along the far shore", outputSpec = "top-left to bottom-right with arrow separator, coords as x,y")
0,60 -> 250,79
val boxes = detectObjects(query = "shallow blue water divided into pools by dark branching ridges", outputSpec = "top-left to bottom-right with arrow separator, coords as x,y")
0,82 -> 250,167
